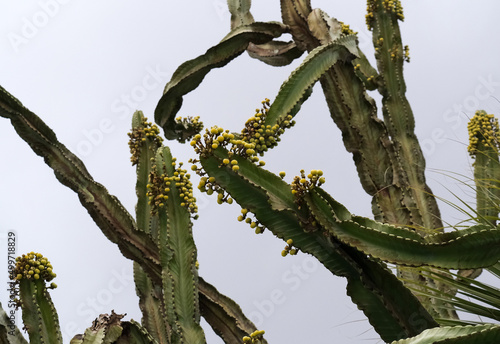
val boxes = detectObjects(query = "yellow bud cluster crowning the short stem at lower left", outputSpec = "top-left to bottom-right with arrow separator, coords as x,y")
10,252 -> 57,289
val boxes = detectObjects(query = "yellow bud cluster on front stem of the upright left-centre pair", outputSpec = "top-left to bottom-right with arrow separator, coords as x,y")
147,158 -> 198,219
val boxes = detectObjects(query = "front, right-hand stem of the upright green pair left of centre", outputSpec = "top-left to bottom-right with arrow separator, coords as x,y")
153,147 -> 205,343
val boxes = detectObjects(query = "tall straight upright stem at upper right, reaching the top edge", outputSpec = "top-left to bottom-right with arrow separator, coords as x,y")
367,0 -> 442,231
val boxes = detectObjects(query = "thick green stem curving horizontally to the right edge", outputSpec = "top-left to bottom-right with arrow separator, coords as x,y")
304,189 -> 500,269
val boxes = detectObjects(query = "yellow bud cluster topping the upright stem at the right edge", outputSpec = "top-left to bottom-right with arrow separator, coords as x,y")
467,110 -> 500,158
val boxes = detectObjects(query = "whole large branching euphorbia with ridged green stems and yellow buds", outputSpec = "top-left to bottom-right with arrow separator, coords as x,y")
0,0 -> 500,343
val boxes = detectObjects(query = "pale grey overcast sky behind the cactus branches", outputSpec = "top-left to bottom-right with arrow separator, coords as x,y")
0,0 -> 500,344
